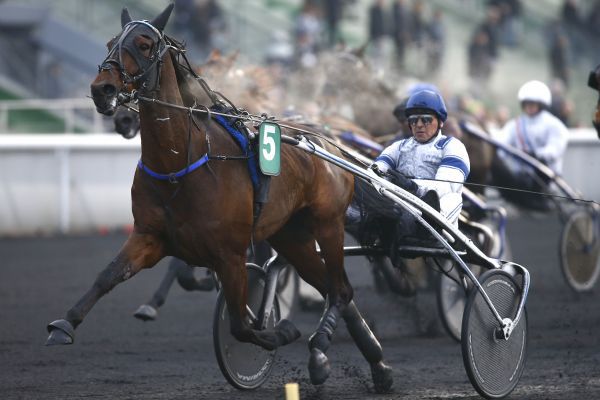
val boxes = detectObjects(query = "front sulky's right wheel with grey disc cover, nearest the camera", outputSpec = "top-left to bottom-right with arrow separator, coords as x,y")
461,270 -> 527,399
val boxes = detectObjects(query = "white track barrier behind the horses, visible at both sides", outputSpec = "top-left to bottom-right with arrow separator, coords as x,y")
0,129 -> 600,236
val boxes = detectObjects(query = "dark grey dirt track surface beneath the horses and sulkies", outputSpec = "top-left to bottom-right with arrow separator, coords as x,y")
0,216 -> 600,400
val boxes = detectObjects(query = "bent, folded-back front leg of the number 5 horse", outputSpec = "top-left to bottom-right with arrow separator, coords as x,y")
215,253 -> 300,350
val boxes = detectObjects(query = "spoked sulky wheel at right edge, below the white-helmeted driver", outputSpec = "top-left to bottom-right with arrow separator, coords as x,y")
560,210 -> 600,292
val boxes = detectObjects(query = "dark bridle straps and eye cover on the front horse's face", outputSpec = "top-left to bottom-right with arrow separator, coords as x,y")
98,21 -> 173,93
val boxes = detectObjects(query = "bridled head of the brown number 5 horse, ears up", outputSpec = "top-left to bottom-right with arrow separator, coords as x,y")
91,3 -> 173,115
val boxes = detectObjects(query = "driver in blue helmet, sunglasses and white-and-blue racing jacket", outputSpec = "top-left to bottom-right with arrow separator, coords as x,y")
370,89 -> 470,231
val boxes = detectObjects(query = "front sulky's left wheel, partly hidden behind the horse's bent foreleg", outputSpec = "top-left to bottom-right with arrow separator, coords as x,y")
213,264 -> 280,390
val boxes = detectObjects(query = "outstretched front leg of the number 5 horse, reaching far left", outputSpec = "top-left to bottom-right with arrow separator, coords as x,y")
46,232 -> 164,345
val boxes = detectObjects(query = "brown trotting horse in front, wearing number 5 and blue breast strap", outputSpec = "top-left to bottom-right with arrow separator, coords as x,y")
47,4 -> 392,391
